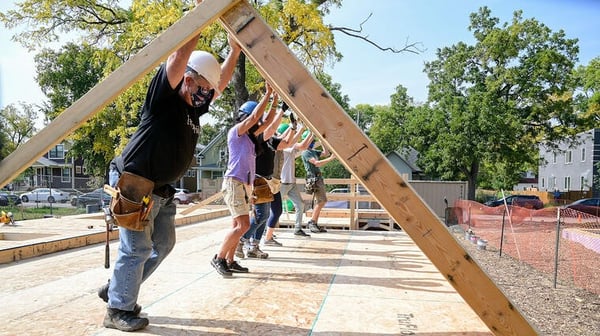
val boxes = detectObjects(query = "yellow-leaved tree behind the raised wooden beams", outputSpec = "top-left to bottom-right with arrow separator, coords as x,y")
0,0 -> 414,174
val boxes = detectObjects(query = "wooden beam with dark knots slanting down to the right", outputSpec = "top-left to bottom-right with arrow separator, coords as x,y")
221,1 -> 537,336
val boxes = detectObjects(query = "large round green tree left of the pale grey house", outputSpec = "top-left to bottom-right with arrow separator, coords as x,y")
401,7 -> 578,199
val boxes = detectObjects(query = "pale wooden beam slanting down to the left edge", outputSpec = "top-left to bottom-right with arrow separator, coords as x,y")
0,0 -> 239,187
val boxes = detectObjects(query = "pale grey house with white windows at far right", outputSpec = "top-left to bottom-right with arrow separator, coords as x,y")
538,129 -> 600,197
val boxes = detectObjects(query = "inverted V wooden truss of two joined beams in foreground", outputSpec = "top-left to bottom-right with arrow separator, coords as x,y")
0,0 -> 537,336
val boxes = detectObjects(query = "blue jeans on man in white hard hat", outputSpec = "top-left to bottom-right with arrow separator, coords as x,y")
108,169 -> 176,311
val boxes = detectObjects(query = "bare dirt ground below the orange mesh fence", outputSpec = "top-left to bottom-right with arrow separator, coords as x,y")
455,232 -> 600,336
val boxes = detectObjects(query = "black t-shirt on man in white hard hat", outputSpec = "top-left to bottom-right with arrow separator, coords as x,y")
122,64 -> 214,187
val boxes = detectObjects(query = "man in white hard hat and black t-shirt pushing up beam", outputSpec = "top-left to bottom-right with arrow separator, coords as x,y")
98,6 -> 241,331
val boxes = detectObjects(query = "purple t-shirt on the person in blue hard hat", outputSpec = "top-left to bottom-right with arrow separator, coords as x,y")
225,124 -> 256,185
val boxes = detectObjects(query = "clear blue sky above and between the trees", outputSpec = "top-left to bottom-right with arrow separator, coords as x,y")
0,0 -> 600,114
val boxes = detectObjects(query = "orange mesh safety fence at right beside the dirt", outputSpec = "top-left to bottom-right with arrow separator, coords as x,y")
452,200 -> 600,294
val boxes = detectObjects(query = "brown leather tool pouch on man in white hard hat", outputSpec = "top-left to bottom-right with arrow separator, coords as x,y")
110,172 -> 154,231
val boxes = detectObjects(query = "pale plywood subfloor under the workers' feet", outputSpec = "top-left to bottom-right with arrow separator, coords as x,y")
0,217 -> 492,336
